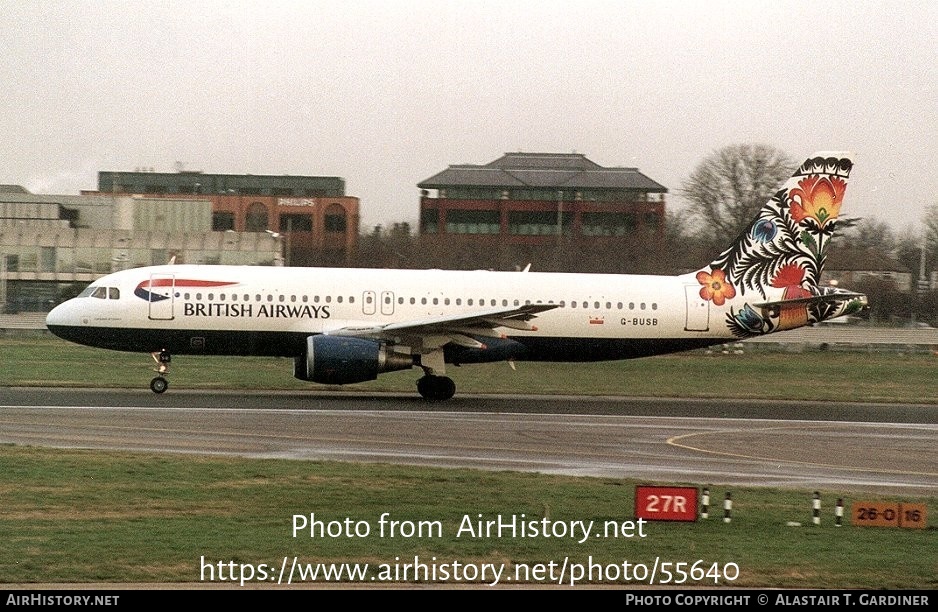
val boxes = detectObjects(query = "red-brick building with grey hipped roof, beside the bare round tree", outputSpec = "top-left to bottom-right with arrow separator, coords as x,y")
417,153 -> 667,245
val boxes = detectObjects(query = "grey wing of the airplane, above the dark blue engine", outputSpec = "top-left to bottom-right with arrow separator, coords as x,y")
325,304 -> 559,348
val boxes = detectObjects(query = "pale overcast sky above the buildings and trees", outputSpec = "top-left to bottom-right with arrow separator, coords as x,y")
0,0 -> 938,232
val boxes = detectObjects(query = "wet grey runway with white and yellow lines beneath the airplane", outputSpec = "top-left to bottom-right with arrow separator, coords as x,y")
0,388 -> 938,496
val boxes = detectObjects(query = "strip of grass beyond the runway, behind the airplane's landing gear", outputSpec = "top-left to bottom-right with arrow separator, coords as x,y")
0,336 -> 938,403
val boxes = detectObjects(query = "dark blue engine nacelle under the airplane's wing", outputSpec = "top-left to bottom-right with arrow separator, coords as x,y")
293,335 -> 414,385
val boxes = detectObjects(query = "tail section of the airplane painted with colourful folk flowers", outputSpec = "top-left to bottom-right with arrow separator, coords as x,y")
695,152 -> 866,337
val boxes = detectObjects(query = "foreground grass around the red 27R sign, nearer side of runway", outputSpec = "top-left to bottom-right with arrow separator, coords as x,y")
0,447 -> 938,589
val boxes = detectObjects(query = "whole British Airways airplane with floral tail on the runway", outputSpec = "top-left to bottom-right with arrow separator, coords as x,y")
46,152 -> 867,401
